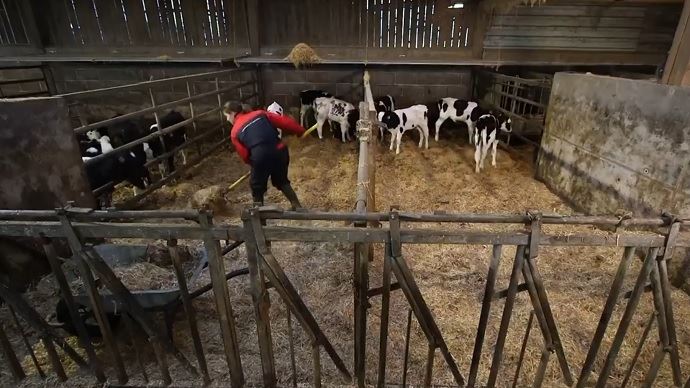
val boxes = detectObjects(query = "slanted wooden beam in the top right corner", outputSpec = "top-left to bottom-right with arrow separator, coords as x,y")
661,0 -> 690,85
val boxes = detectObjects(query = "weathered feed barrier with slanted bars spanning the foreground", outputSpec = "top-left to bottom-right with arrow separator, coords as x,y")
0,208 -> 690,387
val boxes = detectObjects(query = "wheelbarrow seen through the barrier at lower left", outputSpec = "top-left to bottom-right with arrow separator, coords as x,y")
50,241 -> 249,341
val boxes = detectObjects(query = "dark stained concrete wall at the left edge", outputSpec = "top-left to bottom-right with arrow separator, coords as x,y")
0,97 -> 95,209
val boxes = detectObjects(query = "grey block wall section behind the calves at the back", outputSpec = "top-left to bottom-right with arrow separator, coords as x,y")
260,64 -> 472,109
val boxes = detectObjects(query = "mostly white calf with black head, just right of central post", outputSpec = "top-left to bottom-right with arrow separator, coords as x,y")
378,105 -> 429,155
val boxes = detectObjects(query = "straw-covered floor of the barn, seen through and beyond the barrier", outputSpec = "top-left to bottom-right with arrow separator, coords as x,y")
0,129 -> 690,387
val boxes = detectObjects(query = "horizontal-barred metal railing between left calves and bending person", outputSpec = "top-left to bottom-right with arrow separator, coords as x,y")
59,67 -> 259,208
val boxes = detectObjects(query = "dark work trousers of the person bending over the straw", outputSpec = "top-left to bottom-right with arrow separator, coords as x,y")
249,144 -> 290,199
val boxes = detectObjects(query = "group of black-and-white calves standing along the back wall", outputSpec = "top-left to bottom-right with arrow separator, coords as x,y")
268,90 -> 512,172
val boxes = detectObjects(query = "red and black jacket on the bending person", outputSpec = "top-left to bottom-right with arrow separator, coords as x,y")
230,110 -> 305,164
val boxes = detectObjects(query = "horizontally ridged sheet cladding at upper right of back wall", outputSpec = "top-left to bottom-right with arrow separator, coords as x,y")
484,3 -> 681,52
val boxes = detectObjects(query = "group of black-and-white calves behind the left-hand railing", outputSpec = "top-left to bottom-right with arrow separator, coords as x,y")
79,110 -> 187,207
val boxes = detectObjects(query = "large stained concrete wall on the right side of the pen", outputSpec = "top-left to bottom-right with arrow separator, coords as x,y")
537,73 -> 690,217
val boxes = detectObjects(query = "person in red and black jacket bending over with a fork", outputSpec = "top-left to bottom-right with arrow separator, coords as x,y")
223,101 -> 305,210
